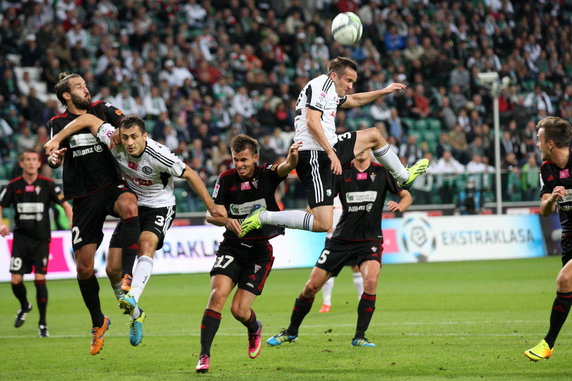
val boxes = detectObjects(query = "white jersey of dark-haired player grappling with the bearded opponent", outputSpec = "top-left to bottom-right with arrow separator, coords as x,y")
97,123 -> 186,208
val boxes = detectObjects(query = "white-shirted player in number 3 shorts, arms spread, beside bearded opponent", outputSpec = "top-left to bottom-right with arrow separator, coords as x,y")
44,114 -> 226,346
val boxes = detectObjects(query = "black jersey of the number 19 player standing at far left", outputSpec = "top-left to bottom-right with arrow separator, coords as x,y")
0,176 -> 64,241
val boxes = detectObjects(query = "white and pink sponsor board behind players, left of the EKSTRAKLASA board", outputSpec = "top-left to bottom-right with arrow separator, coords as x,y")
0,225 -> 326,281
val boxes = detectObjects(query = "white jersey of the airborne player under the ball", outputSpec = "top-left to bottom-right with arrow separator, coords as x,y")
294,74 -> 347,151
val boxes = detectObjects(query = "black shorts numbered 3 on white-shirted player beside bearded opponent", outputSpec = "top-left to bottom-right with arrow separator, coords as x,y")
109,205 -> 177,250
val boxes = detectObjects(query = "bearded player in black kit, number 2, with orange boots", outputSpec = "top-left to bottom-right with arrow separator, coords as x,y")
48,73 -> 139,355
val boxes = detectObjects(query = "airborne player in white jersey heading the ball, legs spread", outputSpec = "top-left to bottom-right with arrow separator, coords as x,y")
241,57 -> 429,236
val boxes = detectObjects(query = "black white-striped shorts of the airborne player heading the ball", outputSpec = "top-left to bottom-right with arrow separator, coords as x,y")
296,132 -> 357,209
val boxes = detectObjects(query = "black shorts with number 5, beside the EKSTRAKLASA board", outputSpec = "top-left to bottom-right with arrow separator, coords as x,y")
316,238 -> 383,276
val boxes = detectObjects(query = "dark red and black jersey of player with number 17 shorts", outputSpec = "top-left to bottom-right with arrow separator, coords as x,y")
213,164 -> 285,240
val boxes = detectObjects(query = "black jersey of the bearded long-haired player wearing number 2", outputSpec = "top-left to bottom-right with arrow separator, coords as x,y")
48,101 -> 123,199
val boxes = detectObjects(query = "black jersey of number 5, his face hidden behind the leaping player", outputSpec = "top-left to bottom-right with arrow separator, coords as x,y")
332,163 -> 400,241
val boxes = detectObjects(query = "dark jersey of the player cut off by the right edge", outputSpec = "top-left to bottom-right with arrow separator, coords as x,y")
540,152 -> 572,236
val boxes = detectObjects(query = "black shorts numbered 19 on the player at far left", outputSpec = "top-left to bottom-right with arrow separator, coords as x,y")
10,233 -> 50,275
